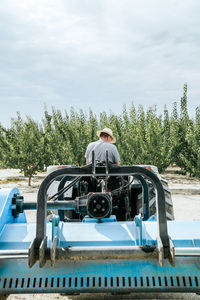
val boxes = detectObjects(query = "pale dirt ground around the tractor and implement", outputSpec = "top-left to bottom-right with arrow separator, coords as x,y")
0,168 -> 200,300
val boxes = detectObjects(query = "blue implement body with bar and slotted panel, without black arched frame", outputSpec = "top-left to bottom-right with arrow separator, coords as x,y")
0,186 -> 200,295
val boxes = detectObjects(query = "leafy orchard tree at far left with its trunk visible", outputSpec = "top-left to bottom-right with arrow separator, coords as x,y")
1,113 -> 44,186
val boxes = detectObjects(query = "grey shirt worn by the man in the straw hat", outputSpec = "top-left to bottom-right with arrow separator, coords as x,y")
85,139 -> 120,164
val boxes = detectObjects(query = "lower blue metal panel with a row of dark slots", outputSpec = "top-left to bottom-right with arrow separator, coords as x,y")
0,258 -> 200,294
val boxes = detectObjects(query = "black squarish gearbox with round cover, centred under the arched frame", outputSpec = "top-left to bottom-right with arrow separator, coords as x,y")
87,193 -> 112,219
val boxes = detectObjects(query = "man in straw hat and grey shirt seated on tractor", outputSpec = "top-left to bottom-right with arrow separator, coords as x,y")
85,128 -> 120,166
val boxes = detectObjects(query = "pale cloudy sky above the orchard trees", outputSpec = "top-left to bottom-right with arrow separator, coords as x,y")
0,0 -> 200,126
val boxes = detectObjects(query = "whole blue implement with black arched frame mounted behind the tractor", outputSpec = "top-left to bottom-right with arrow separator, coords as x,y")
0,161 -> 200,294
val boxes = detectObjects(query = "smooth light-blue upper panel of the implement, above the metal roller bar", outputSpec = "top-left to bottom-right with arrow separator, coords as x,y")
0,221 -> 200,249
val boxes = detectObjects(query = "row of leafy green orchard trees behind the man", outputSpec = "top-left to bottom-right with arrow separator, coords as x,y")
0,84 -> 200,185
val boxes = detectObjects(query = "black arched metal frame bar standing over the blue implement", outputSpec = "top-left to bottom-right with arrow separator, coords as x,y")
29,164 -> 173,267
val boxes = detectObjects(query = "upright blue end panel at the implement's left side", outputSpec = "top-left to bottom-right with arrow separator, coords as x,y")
0,188 -> 26,232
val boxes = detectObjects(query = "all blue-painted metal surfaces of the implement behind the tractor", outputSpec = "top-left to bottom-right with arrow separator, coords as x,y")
0,189 -> 200,294
